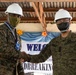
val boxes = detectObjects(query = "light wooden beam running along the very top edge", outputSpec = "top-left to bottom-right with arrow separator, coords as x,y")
0,0 -> 76,2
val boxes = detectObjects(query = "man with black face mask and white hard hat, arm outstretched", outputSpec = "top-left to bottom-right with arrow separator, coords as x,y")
20,9 -> 76,75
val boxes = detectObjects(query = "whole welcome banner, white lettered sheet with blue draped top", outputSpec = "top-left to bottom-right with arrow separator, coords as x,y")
21,32 -> 60,75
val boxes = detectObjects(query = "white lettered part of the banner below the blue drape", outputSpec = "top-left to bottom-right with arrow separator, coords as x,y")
21,40 -> 53,74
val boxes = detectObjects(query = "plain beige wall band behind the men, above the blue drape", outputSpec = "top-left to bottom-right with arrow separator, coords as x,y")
17,23 -> 76,32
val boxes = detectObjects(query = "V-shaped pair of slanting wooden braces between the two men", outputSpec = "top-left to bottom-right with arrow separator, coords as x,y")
32,2 -> 47,32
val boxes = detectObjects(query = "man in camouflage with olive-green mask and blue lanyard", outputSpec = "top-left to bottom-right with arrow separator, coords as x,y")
0,3 -> 24,75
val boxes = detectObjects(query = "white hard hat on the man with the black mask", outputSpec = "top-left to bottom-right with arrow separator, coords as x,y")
54,9 -> 72,21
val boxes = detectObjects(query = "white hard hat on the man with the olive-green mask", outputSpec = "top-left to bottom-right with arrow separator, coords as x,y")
5,3 -> 23,16
